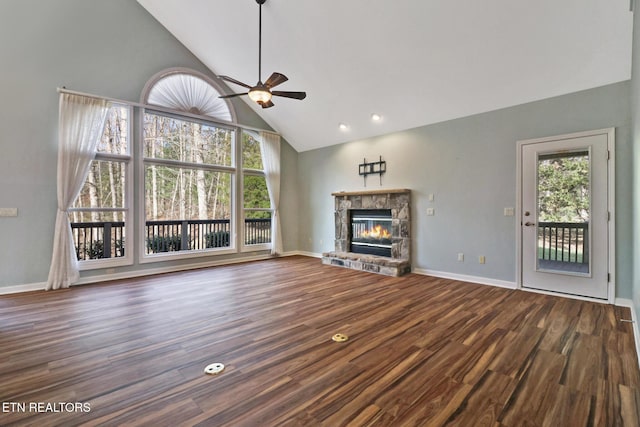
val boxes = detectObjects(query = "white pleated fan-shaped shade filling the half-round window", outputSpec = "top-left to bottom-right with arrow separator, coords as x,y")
147,74 -> 232,122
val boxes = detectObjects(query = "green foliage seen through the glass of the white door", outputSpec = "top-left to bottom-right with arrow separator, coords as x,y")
538,154 -> 589,222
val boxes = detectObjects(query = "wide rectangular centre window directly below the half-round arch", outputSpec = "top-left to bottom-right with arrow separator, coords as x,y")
143,112 -> 235,255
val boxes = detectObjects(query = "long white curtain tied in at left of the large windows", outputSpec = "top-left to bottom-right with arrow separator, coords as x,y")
46,93 -> 110,290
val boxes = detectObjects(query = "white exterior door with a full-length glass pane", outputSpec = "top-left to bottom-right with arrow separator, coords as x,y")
518,129 -> 614,299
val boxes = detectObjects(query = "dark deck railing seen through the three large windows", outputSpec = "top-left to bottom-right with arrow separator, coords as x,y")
71,218 -> 271,260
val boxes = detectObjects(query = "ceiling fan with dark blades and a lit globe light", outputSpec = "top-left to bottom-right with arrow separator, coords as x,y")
219,0 -> 307,108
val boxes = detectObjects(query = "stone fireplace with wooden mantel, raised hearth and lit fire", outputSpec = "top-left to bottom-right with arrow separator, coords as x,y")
322,189 -> 411,276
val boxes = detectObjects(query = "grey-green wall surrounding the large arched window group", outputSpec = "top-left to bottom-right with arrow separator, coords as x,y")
0,0 -> 298,287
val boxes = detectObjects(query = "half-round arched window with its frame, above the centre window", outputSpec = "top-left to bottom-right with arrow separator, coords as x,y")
142,68 -> 236,122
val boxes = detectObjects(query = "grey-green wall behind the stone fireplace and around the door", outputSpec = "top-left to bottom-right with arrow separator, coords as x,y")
298,82 -> 632,298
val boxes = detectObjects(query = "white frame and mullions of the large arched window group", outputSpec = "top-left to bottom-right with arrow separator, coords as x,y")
69,68 -> 274,273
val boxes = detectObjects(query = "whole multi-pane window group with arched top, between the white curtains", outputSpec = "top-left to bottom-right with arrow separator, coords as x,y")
69,69 -> 279,269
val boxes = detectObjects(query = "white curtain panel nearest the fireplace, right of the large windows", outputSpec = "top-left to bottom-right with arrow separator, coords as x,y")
260,132 -> 283,255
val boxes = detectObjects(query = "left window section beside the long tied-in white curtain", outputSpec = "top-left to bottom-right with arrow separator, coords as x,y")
69,105 -> 132,268
